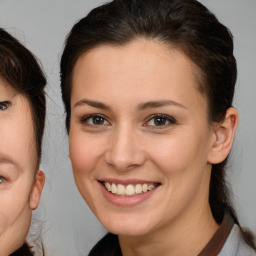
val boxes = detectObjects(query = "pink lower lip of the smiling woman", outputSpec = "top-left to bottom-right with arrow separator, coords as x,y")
99,182 -> 159,206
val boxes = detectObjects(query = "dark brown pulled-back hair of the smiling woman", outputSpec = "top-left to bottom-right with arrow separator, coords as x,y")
60,0 -> 255,248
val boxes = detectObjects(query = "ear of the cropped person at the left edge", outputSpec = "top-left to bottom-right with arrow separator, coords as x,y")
29,170 -> 45,210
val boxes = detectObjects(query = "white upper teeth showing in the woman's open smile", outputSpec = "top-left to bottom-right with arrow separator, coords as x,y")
104,182 -> 156,196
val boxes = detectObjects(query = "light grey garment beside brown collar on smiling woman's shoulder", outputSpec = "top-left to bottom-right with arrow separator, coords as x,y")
218,224 -> 256,256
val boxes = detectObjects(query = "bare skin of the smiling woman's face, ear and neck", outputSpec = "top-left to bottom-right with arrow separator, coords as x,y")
70,39 -> 237,255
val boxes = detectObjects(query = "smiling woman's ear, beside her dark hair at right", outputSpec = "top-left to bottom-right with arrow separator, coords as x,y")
208,108 -> 238,164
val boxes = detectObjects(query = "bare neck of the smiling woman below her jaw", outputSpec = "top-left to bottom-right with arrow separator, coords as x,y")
119,205 -> 218,256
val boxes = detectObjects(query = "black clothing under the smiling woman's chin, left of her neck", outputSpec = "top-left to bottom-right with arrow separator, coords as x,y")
89,233 -> 122,256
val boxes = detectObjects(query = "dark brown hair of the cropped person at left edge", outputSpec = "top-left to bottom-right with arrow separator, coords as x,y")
0,28 -> 46,168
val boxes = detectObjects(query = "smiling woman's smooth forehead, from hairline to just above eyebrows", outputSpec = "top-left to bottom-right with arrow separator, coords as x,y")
72,39 -> 204,103
